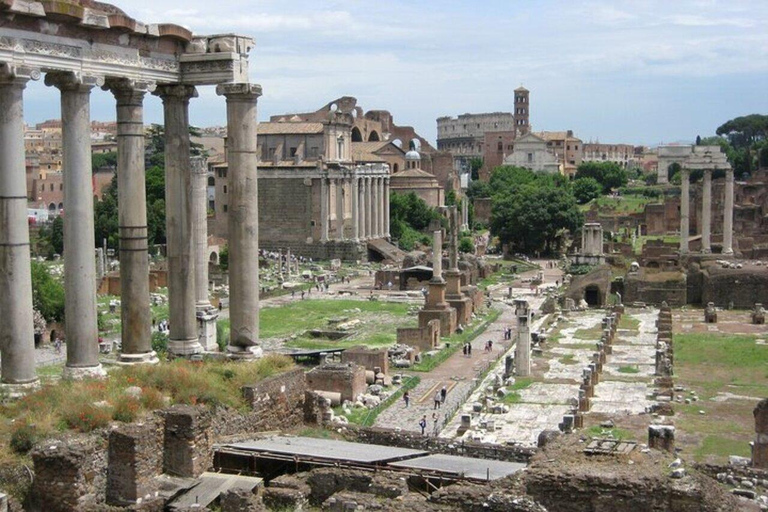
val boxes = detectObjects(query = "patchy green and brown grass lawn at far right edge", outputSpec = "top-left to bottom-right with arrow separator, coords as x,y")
674,333 -> 768,463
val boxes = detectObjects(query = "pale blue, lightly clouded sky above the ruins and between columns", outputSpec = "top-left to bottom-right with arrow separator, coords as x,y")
25,0 -> 768,145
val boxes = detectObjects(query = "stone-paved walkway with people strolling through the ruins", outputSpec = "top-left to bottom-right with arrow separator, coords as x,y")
375,262 -> 562,435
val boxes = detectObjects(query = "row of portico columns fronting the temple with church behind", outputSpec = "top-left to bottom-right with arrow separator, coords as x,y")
320,176 -> 389,242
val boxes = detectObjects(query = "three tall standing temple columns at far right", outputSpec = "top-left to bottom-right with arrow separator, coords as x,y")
680,168 -> 734,254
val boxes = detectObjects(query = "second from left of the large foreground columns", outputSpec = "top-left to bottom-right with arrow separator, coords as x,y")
45,73 -> 105,378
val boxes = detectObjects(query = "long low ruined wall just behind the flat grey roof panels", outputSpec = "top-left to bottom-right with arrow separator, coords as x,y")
345,427 -> 536,462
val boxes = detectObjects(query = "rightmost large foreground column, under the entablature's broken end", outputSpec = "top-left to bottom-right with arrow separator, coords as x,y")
216,84 -> 262,358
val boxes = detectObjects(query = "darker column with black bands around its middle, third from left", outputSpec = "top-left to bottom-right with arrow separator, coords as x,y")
106,79 -> 158,364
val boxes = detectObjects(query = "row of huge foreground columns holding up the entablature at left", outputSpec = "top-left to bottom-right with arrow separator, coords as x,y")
0,66 -> 261,385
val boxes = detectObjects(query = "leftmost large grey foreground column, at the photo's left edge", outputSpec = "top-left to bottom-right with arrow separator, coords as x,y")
0,68 -> 40,391
